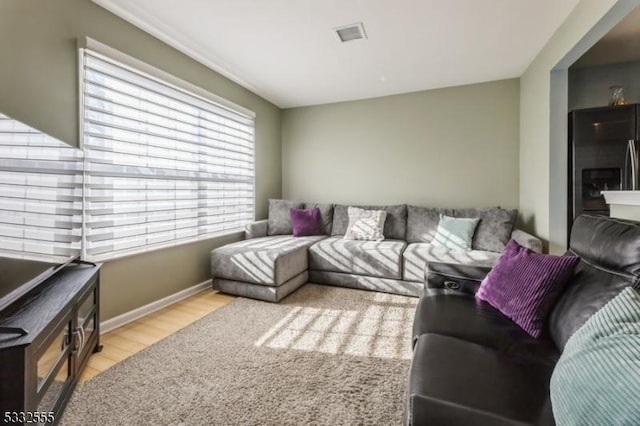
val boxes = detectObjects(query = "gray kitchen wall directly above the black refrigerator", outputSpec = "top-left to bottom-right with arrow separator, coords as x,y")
569,62 -> 640,110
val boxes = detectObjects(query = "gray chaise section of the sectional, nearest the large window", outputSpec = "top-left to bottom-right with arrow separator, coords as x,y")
211,235 -> 326,302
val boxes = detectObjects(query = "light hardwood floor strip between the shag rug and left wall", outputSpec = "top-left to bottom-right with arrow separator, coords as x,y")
79,289 -> 233,383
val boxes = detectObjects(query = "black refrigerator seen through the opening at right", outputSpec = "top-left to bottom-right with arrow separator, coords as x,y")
568,104 -> 640,230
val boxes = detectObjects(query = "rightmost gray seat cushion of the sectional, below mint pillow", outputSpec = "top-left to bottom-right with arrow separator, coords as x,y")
403,243 -> 500,282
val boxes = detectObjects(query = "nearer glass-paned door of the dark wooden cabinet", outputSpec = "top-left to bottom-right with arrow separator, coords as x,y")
32,312 -> 73,412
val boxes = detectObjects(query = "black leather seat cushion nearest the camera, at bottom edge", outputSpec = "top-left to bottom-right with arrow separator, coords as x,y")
408,334 -> 554,426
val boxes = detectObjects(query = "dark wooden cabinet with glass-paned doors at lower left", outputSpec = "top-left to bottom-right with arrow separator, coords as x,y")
0,265 -> 100,424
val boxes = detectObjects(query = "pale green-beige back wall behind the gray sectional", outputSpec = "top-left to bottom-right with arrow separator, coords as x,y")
282,79 -> 519,211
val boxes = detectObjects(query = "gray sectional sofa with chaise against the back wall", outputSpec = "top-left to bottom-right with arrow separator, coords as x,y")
211,200 -> 542,302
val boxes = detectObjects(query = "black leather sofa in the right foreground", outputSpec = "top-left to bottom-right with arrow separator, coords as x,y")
405,215 -> 640,426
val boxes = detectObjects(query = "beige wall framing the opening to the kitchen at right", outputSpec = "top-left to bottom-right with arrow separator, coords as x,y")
520,0 -> 640,253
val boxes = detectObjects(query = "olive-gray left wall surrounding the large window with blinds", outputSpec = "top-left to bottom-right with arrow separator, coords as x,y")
0,0 -> 282,320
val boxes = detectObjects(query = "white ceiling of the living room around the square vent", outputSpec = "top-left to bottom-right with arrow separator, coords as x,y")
93,0 -> 578,108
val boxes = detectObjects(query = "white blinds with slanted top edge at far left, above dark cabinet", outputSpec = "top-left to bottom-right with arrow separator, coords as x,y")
0,114 -> 82,261
